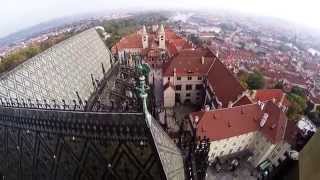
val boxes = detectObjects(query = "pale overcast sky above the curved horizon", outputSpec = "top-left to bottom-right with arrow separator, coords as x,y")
0,0 -> 320,37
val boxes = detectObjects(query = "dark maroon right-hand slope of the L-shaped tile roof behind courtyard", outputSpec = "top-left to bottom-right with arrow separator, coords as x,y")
208,60 -> 245,107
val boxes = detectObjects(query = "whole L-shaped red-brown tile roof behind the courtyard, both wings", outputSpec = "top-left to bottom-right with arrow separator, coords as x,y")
163,48 -> 244,107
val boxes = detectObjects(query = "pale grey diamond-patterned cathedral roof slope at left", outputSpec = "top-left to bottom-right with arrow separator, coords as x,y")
0,28 -> 111,103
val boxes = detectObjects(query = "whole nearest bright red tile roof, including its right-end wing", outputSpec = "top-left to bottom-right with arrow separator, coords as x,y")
191,101 -> 287,144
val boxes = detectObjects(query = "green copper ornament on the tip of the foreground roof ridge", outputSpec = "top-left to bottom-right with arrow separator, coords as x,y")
136,75 -> 152,127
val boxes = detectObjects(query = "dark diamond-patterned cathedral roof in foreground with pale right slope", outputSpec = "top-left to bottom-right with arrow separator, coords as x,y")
0,106 -> 184,180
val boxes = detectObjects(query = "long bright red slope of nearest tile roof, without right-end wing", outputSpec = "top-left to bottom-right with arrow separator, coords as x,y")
191,104 -> 262,141
